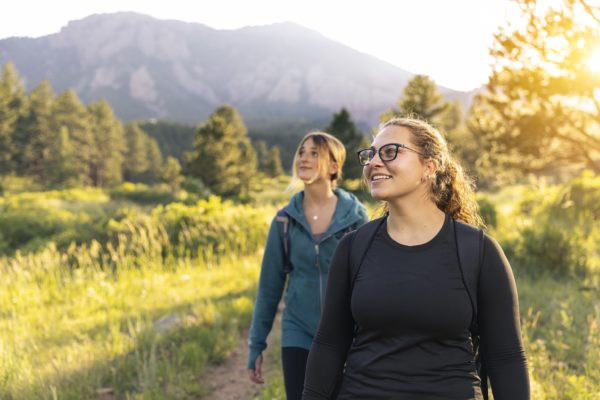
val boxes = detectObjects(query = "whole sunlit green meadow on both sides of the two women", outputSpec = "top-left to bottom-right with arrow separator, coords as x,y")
0,174 -> 600,400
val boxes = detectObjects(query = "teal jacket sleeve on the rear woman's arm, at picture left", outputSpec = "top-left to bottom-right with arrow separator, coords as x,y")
247,219 -> 286,369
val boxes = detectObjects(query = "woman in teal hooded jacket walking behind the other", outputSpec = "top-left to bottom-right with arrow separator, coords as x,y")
248,132 -> 368,400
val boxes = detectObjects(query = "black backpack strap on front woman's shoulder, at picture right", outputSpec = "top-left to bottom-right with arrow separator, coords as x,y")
453,220 -> 488,400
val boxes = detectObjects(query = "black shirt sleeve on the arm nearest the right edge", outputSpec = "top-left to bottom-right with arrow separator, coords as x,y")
477,236 -> 529,400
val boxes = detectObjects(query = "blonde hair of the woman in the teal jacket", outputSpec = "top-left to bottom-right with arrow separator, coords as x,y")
290,131 -> 346,187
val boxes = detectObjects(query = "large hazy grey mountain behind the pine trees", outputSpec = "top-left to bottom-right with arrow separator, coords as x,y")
0,12 -> 476,126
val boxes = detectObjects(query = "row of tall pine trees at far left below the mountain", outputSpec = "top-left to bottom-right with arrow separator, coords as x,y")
0,63 -> 169,188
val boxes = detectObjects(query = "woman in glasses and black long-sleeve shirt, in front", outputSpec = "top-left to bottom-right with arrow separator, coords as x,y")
303,119 -> 529,400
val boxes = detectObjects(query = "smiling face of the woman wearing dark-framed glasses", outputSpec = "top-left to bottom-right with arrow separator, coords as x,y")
363,125 -> 435,201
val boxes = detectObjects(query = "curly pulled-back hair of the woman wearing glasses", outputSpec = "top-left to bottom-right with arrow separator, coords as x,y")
379,118 -> 484,227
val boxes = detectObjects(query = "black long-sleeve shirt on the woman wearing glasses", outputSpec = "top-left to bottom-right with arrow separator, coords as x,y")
303,217 -> 529,400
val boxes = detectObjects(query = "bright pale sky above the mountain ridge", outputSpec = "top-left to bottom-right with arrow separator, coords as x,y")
0,0 -> 516,91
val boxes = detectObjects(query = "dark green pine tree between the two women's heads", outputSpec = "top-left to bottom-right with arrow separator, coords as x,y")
325,108 -> 369,179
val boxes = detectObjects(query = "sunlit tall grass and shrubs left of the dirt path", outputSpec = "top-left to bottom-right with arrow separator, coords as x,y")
0,193 -> 271,399
